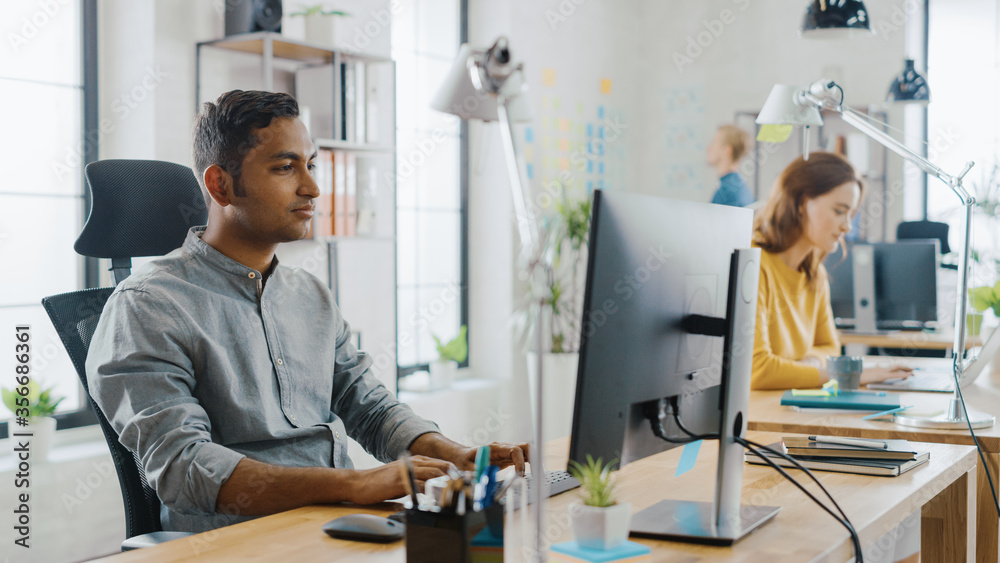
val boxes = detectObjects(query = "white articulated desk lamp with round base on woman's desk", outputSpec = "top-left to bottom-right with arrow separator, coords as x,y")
757,80 -> 995,430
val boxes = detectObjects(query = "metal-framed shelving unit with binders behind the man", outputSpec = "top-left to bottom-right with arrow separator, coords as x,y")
195,32 -> 397,389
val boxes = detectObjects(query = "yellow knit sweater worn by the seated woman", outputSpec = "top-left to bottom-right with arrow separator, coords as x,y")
750,251 -> 840,389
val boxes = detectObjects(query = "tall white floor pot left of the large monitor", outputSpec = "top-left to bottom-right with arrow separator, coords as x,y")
527,352 -> 580,441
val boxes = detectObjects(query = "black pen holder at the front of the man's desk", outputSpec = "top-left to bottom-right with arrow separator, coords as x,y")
406,503 -> 504,563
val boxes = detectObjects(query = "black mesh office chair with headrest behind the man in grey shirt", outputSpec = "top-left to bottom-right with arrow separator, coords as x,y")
42,160 -> 208,551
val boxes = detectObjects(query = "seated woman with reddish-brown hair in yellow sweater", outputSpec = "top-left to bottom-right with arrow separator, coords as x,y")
751,152 -> 910,389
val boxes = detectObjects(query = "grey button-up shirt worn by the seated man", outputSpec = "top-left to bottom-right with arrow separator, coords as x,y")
87,227 -> 438,531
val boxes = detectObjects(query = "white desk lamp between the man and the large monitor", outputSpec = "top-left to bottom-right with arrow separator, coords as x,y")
431,37 -> 553,561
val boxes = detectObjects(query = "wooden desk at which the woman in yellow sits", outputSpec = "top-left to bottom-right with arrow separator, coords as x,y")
748,364 -> 1000,563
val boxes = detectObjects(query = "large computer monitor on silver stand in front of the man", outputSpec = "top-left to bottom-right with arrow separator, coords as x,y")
569,190 -> 778,545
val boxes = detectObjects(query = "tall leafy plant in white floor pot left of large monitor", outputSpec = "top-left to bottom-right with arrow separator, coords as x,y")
512,197 -> 592,440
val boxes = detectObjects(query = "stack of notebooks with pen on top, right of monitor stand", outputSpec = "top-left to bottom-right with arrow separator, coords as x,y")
744,436 -> 931,477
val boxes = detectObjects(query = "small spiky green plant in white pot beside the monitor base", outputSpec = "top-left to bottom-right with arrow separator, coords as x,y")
569,454 -> 632,550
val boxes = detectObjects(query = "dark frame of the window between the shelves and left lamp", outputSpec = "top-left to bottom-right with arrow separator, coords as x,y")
396,0 -> 472,383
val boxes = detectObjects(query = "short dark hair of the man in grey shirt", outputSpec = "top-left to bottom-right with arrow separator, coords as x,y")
194,90 -> 299,204
